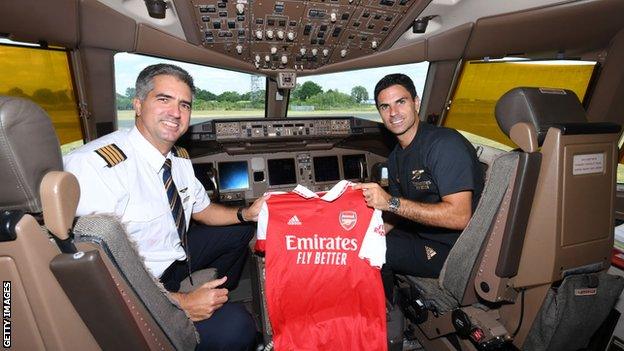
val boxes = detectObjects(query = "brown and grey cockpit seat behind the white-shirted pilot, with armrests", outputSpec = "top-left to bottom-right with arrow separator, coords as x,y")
0,96 -> 197,350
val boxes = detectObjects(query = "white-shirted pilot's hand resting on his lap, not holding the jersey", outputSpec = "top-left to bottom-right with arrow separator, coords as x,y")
171,277 -> 228,322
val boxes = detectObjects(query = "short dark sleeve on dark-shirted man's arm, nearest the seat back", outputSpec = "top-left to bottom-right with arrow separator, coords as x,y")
427,132 -> 478,197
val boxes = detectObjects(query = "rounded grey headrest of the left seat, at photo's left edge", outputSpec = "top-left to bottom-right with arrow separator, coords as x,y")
0,96 -> 63,213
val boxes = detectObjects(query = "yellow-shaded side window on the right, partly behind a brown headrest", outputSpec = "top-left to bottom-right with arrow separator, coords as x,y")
442,60 -> 596,150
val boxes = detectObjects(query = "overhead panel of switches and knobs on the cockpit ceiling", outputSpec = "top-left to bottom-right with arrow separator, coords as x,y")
190,0 -> 429,70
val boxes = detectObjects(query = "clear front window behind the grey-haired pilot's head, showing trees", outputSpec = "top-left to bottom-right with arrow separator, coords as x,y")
115,53 -> 266,129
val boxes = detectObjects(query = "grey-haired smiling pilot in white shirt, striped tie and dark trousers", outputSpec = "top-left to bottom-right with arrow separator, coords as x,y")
64,64 -> 264,350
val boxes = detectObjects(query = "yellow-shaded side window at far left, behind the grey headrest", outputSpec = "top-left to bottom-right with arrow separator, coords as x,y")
0,40 -> 84,154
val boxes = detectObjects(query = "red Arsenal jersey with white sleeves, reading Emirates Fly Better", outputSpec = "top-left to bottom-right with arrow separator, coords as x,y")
256,181 -> 387,351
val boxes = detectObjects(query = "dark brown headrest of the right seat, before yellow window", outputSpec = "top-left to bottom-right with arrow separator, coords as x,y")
495,87 -> 587,145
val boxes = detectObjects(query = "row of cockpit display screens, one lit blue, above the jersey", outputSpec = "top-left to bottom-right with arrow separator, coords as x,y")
193,148 -> 386,203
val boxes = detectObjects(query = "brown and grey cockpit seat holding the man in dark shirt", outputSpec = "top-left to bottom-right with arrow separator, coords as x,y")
398,88 -> 623,350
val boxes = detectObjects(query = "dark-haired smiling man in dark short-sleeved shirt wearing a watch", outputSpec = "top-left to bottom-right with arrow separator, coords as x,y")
356,74 -> 484,299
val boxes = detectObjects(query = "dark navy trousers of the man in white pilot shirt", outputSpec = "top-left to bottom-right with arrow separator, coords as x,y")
160,225 -> 256,350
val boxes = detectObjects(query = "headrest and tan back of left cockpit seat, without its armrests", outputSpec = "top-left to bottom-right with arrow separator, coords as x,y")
0,96 -> 99,350
